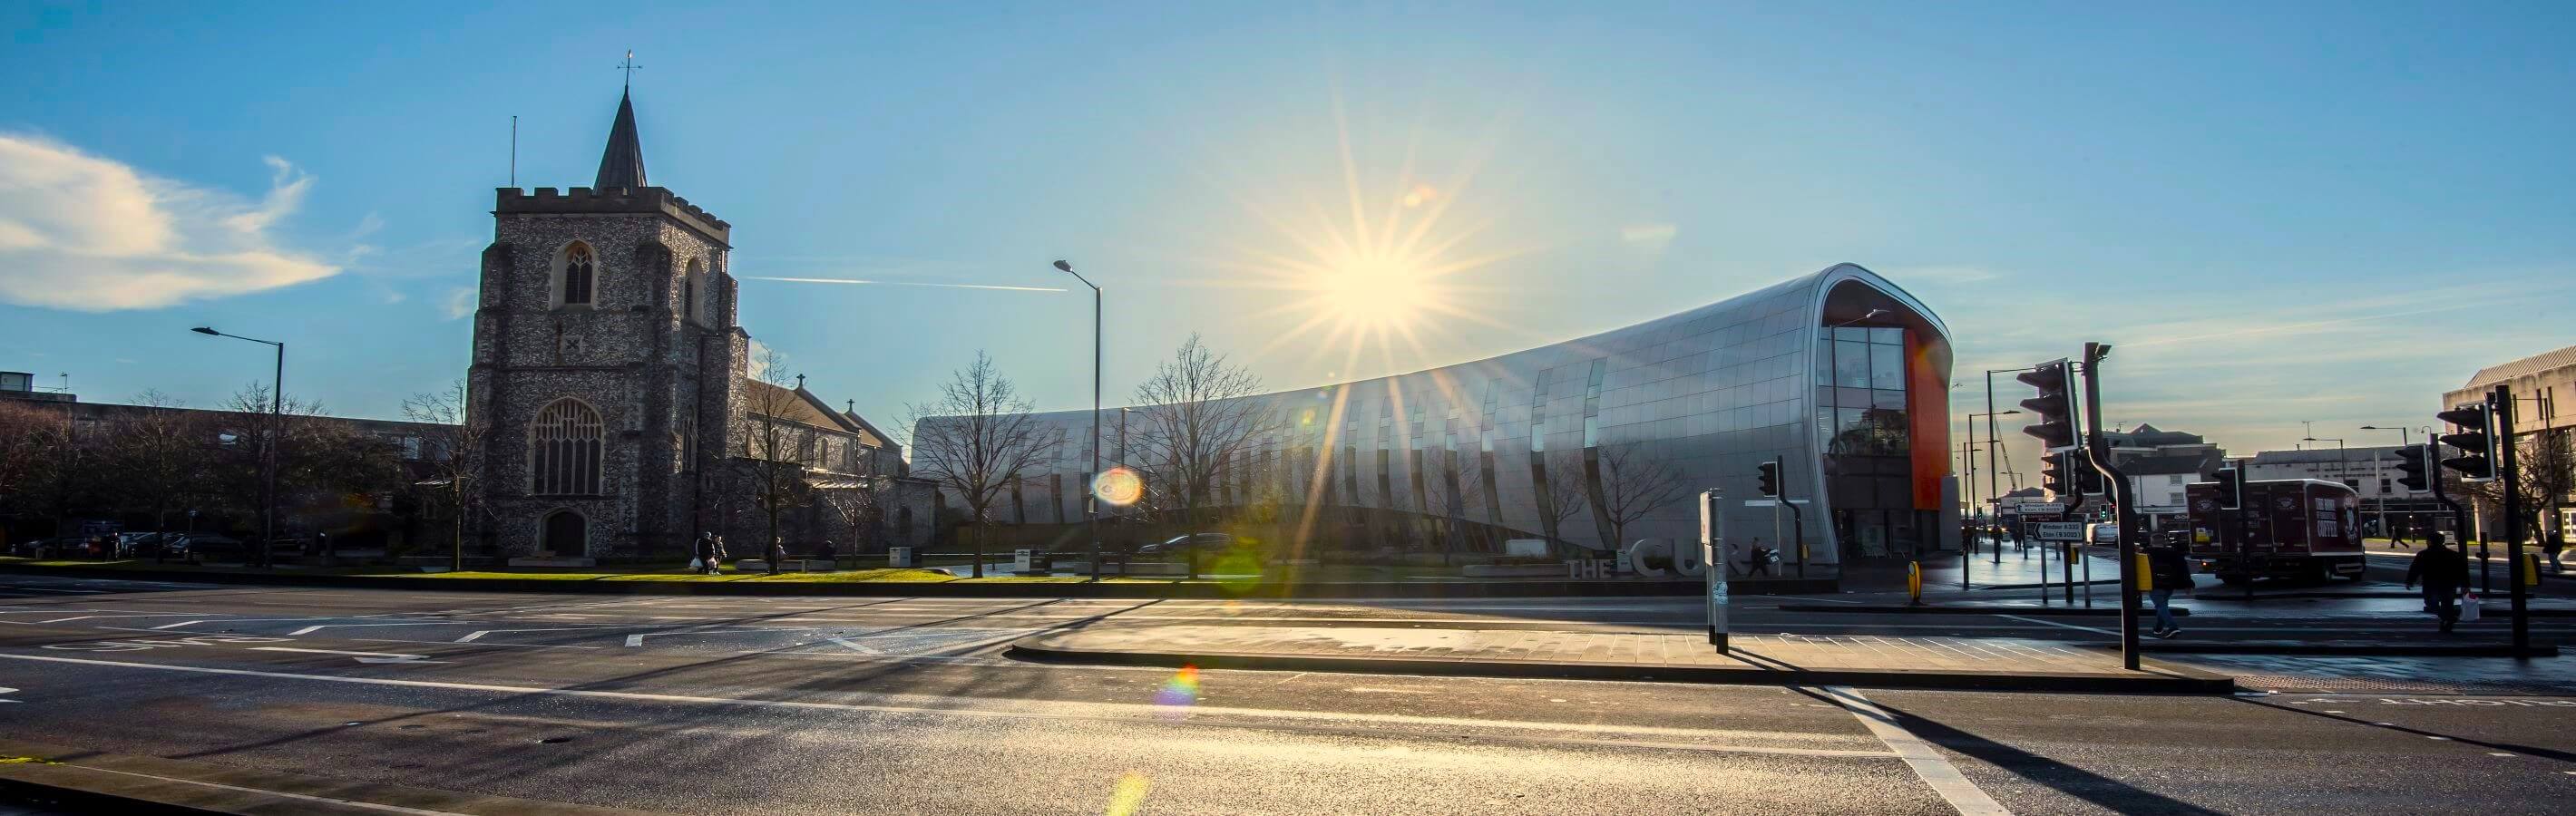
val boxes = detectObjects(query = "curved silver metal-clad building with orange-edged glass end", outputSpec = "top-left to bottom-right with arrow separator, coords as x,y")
948,263 -> 1957,574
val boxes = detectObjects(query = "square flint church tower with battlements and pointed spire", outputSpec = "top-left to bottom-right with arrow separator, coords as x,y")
469,92 -> 749,564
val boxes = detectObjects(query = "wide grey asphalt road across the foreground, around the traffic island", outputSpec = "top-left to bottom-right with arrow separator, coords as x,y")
0,577 -> 2576,813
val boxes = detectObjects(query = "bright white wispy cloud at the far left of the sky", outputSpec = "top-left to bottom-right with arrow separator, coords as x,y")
0,134 -> 340,312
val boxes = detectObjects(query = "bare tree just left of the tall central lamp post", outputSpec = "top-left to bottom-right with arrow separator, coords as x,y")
910,350 -> 1056,577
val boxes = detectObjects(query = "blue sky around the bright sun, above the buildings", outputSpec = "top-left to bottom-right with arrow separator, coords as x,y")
0,3 -> 2576,471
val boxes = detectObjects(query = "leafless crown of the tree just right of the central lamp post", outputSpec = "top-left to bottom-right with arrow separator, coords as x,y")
1131,335 -> 1280,520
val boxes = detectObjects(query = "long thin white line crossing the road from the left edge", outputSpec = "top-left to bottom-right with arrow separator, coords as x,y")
0,651 -> 1906,756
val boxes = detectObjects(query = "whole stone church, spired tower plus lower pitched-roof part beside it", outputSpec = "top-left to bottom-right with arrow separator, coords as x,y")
469,87 -> 932,564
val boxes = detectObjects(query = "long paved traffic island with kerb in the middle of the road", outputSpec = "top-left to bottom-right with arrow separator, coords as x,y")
1010,626 -> 2233,693
